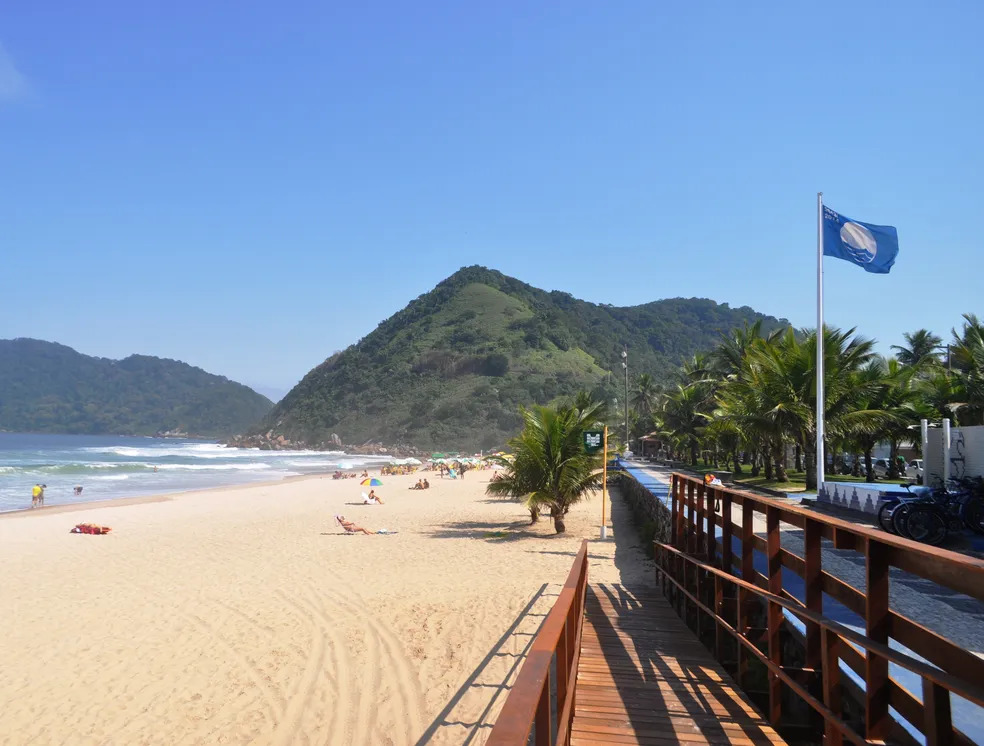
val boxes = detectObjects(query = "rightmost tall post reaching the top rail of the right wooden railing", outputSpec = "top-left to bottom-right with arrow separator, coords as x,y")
864,538 -> 890,741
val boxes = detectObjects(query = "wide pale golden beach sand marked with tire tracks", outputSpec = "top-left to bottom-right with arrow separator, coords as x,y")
0,464 -> 653,744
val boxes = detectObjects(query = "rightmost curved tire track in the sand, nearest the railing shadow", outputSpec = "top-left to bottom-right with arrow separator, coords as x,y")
307,578 -> 426,739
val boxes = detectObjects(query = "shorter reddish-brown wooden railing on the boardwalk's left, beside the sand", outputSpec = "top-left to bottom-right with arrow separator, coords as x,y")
486,541 -> 588,746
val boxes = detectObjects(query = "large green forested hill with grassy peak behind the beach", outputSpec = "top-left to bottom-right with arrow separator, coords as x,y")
252,266 -> 786,450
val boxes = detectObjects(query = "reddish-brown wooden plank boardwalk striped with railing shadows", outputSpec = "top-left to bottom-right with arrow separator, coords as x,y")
571,583 -> 784,746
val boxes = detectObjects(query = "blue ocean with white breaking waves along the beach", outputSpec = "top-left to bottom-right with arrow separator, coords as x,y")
0,433 -> 389,512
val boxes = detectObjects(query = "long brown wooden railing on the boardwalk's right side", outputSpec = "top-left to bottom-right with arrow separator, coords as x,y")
656,474 -> 984,746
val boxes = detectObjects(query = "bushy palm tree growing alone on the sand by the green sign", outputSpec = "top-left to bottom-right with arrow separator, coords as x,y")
486,404 -> 604,534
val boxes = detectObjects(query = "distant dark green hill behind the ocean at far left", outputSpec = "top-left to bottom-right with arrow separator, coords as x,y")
0,339 -> 273,436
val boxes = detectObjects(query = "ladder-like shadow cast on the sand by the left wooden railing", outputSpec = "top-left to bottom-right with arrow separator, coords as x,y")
415,583 -> 557,746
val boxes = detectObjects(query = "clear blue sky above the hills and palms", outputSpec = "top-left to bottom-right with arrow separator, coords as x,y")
0,0 -> 984,398
